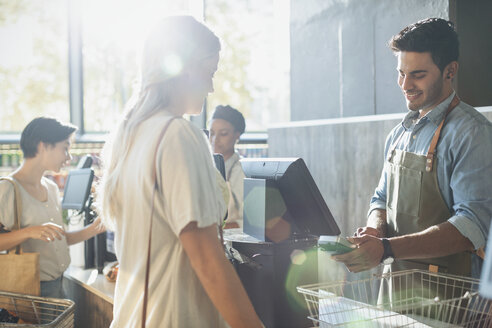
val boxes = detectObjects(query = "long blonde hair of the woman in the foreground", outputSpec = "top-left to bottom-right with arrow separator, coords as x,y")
97,16 -> 220,228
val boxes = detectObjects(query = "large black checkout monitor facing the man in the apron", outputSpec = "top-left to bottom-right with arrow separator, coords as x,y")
241,158 -> 340,239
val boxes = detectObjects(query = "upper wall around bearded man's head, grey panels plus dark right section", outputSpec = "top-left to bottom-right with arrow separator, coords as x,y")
290,0 -> 492,121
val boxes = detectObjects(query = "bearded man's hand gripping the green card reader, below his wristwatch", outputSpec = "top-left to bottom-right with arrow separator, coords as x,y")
331,234 -> 384,272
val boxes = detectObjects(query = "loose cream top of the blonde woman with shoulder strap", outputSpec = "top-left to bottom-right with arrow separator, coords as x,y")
111,112 -> 225,328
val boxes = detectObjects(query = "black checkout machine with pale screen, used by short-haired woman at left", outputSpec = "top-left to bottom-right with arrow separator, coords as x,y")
62,155 -> 116,273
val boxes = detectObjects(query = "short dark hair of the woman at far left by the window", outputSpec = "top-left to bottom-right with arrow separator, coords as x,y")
20,117 -> 77,158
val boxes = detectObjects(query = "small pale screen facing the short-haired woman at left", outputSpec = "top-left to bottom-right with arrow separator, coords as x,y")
62,168 -> 94,211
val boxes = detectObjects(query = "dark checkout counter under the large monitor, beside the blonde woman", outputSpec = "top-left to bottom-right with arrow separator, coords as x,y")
224,229 -> 318,328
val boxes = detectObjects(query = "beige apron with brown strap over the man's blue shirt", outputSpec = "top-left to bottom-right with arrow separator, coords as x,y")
380,96 -> 471,301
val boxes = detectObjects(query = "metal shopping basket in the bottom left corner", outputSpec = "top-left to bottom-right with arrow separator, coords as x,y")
0,291 -> 75,328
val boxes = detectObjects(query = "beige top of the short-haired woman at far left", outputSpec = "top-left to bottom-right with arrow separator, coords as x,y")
0,177 -> 70,281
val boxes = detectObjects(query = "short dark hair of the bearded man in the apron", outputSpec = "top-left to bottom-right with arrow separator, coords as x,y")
389,18 -> 459,72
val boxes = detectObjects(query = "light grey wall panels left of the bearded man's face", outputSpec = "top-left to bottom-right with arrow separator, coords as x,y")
290,0 -> 449,121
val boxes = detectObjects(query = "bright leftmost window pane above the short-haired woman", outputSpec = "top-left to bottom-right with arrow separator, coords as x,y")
0,0 -> 70,133
